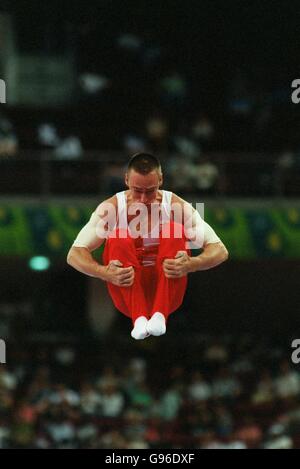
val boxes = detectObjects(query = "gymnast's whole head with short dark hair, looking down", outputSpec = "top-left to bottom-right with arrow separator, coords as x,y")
125,153 -> 163,204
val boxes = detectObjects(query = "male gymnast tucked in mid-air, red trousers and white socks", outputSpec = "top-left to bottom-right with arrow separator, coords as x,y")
67,153 -> 228,340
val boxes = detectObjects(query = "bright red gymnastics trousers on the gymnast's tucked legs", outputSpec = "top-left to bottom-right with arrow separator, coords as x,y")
103,222 -> 190,322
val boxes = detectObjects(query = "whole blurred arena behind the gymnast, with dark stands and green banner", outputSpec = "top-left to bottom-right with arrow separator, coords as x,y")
0,0 -> 300,450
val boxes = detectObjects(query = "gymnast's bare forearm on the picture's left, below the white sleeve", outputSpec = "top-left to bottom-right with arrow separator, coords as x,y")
67,247 -> 105,280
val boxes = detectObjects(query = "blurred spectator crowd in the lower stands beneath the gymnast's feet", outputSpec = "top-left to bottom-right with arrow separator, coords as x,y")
0,335 -> 300,449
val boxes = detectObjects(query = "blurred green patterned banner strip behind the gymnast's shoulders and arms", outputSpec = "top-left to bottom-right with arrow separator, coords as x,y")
0,202 -> 300,259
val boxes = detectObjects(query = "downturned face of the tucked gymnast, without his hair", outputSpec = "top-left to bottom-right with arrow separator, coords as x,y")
125,169 -> 162,205
